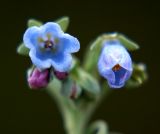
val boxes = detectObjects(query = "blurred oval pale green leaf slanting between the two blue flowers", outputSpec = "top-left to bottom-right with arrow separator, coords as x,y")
71,68 -> 100,95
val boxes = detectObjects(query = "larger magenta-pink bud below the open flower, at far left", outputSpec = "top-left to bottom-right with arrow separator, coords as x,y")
28,68 -> 49,89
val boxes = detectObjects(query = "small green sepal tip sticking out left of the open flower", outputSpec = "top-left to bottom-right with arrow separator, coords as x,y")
17,43 -> 29,56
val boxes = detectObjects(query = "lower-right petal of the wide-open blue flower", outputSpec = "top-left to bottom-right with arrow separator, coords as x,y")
51,53 -> 72,72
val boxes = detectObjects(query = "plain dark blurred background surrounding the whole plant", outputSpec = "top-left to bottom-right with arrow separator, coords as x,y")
0,0 -> 160,134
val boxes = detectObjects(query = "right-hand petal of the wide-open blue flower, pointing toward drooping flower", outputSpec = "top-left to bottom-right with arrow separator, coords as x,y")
60,34 -> 80,53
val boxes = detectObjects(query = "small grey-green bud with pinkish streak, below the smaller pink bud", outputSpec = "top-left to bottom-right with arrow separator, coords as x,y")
61,77 -> 82,99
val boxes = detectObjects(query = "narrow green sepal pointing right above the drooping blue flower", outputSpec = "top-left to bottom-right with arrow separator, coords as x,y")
117,34 -> 139,51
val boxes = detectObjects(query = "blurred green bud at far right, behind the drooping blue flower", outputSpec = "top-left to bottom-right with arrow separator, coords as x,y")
125,63 -> 148,88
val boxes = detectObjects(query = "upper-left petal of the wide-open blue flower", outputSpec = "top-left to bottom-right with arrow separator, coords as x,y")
23,26 -> 40,49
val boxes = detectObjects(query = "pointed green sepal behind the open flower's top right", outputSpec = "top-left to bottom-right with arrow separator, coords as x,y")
55,16 -> 69,32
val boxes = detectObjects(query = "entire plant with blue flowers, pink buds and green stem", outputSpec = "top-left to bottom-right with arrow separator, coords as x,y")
17,17 -> 147,134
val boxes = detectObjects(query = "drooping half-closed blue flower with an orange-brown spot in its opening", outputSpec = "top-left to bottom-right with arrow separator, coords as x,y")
98,40 -> 133,88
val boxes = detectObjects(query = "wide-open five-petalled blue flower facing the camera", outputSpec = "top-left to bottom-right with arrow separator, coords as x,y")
23,22 -> 80,72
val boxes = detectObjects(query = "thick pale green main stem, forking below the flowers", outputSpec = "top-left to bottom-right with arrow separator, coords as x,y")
47,78 -> 109,134
